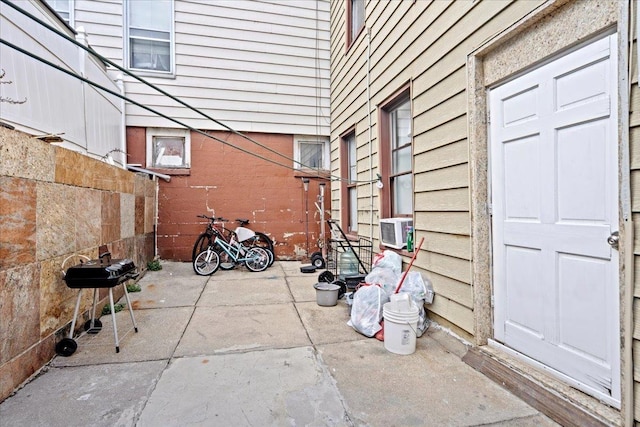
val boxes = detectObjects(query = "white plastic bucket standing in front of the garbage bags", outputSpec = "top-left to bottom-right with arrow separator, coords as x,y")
382,301 -> 420,354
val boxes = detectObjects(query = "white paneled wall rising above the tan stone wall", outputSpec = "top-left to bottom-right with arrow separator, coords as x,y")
0,1 -> 123,160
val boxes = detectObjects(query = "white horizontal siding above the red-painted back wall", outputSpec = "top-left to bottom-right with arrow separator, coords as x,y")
75,0 -> 329,135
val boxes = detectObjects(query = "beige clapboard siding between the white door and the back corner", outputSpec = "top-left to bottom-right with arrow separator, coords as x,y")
330,0 -> 552,335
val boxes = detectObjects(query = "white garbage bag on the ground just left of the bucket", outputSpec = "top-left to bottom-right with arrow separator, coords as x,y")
347,285 -> 389,337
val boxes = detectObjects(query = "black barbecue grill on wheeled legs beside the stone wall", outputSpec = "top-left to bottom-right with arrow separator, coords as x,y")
56,251 -> 138,356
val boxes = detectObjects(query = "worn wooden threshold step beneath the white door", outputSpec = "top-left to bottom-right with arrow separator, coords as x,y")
462,345 -> 622,426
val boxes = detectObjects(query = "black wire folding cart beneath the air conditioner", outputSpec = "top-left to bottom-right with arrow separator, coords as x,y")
318,219 -> 373,296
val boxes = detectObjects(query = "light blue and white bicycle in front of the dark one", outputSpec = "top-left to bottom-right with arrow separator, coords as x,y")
193,227 -> 269,276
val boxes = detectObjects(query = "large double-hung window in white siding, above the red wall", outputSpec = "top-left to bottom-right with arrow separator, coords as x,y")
126,0 -> 173,73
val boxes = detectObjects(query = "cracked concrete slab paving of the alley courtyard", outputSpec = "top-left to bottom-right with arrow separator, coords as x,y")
0,262 -> 555,427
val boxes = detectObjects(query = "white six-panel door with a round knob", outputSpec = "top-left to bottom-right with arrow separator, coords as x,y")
489,35 -> 620,407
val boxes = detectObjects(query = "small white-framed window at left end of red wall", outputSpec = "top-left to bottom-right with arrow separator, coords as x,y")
147,128 -> 191,169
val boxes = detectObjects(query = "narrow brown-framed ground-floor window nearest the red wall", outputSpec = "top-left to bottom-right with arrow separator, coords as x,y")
340,132 -> 358,234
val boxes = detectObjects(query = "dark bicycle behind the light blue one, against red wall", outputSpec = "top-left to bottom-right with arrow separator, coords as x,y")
191,215 -> 275,270
